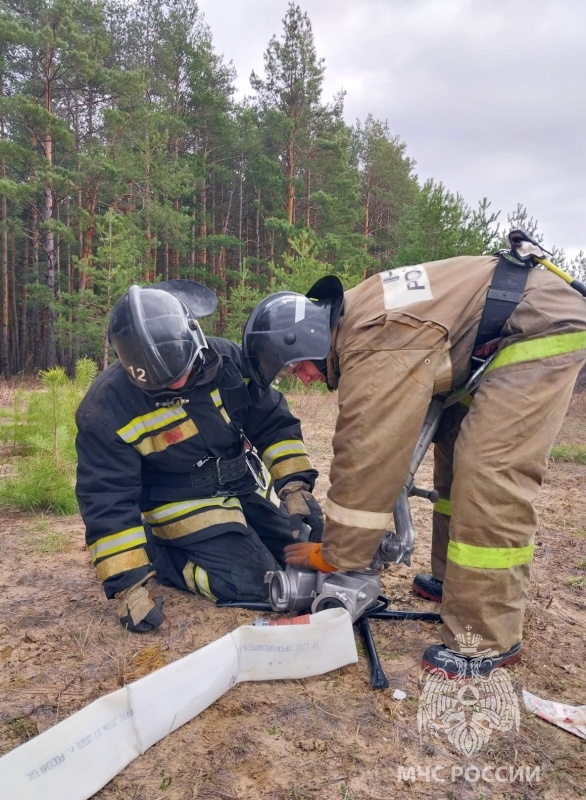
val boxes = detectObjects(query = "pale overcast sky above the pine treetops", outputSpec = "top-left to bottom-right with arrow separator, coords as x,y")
198,0 -> 586,255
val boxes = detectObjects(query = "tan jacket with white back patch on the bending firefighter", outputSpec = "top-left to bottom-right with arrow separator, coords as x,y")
323,256 -> 586,570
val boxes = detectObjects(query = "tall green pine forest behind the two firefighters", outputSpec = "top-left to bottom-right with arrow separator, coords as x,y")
0,0 -> 585,378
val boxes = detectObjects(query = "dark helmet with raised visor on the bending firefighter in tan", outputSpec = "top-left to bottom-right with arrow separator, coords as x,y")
242,275 -> 344,389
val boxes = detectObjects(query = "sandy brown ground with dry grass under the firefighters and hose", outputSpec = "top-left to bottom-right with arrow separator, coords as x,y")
0,394 -> 586,800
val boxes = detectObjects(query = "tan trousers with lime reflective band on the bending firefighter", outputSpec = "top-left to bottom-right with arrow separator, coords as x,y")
432,352 -> 586,653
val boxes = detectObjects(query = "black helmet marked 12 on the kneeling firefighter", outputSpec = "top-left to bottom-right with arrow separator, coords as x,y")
108,280 -> 218,391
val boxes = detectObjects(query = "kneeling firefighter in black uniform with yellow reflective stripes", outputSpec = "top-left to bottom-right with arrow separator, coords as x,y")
76,280 -> 323,632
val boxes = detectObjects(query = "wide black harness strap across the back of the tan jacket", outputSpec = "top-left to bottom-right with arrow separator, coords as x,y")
473,253 -> 530,352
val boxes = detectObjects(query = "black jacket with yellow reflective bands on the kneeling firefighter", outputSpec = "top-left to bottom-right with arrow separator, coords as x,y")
76,337 -> 317,597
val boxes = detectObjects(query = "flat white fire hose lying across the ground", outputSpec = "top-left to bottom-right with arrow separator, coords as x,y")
0,608 -> 358,800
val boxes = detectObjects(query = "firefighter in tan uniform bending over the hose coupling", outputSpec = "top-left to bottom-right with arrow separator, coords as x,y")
243,238 -> 586,671
